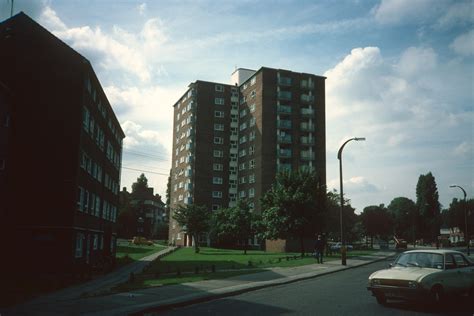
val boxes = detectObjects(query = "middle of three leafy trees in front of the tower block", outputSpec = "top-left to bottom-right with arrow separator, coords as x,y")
213,200 -> 260,254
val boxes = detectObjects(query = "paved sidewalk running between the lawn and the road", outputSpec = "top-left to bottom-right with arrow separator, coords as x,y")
2,252 -> 396,316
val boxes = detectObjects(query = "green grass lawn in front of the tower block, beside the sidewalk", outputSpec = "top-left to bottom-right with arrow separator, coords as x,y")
113,247 -> 374,292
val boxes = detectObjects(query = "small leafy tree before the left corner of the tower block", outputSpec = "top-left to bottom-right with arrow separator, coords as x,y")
173,204 -> 211,253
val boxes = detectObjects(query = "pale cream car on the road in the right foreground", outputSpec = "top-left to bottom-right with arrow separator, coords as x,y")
367,250 -> 474,304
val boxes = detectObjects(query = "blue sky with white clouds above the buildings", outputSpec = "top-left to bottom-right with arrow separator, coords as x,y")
0,0 -> 474,213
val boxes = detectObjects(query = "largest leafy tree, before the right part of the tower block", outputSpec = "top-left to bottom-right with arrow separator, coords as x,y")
261,171 -> 326,254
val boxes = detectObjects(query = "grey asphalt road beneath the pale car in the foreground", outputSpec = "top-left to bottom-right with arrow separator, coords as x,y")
158,261 -> 474,316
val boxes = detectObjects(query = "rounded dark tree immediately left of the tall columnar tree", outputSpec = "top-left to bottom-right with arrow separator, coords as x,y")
388,197 -> 419,241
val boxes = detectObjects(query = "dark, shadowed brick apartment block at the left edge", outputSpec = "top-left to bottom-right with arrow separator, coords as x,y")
0,13 -> 125,276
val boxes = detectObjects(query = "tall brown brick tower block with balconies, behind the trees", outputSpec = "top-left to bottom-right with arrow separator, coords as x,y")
169,67 -> 326,249
